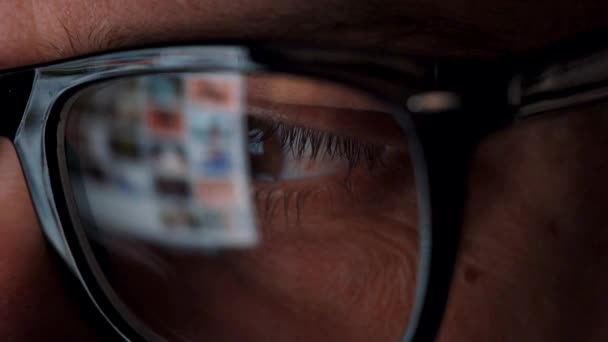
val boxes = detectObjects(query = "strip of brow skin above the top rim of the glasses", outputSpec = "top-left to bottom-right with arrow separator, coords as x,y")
0,0 -> 608,68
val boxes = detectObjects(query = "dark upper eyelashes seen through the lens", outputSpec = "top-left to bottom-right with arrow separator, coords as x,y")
249,119 -> 385,170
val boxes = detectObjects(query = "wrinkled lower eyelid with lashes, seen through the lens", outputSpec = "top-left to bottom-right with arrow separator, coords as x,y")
252,149 -> 413,233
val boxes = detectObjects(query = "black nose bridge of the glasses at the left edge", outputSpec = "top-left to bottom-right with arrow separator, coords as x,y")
0,70 -> 35,140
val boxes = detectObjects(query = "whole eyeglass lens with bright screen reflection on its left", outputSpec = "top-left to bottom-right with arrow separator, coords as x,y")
61,73 -> 419,341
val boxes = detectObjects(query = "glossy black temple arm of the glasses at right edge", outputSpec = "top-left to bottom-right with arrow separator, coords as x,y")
509,50 -> 608,119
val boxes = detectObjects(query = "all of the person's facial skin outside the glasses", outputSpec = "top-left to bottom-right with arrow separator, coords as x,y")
0,0 -> 608,341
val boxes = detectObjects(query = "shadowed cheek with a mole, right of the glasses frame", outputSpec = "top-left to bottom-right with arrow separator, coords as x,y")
440,107 -> 608,341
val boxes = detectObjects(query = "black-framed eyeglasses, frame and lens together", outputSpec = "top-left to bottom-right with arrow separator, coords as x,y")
0,35 -> 608,341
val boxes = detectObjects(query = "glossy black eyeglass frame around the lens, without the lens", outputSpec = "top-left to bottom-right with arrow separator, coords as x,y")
0,34 -> 608,341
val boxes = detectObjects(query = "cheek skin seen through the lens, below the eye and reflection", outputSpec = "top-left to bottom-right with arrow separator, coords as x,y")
102,162 -> 418,341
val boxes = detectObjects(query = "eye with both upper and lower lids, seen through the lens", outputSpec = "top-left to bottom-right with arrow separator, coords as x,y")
240,77 -> 414,231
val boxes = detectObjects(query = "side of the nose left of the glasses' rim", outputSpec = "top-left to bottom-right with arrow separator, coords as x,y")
0,138 -> 101,342
